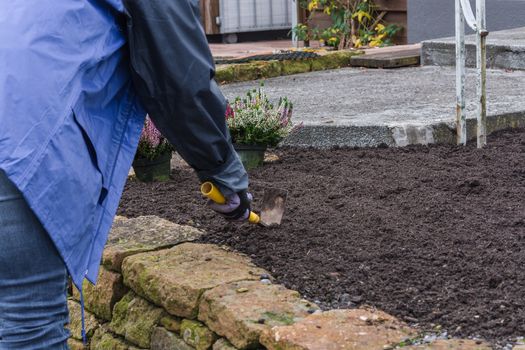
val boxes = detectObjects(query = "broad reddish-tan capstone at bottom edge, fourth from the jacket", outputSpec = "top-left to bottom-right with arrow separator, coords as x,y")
261,309 -> 416,350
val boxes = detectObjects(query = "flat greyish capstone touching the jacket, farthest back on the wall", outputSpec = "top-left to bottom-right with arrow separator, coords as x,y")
102,216 -> 203,272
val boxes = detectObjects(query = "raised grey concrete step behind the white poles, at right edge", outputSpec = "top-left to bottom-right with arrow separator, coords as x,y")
421,26 -> 525,70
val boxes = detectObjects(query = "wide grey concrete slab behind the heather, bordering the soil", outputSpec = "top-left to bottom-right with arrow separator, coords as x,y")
222,66 -> 525,148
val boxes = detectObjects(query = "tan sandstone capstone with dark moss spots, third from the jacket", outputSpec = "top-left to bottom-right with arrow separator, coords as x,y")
199,281 -> 318,349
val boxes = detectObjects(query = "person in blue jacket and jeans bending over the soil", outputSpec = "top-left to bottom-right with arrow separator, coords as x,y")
0,0 -> 250,349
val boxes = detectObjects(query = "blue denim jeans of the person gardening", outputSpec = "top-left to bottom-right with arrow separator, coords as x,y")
0,170 -> 69,350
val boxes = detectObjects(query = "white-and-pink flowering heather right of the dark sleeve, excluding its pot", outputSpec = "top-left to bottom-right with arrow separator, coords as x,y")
226,85 -> 300,147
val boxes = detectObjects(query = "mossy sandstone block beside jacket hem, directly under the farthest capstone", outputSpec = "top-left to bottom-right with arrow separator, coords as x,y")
73,267 -> 128,321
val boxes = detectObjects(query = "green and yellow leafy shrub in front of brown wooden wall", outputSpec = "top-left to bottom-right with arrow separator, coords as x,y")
292,0 -> 401,49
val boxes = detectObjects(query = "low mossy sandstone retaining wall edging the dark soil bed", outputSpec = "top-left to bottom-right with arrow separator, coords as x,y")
68,216 -> 490,350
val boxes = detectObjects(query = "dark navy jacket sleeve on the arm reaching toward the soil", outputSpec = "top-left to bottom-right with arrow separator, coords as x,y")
124,0 -> 248,195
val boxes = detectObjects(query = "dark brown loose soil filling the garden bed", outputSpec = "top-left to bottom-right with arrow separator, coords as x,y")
119,130 -> 525,342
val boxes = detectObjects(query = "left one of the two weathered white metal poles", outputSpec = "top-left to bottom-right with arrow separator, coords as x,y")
456,0 -> 467,145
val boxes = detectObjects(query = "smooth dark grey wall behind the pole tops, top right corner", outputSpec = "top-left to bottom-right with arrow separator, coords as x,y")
407,0 -> 525,43
